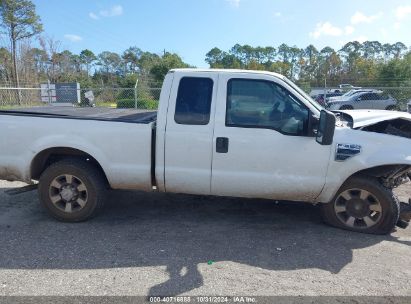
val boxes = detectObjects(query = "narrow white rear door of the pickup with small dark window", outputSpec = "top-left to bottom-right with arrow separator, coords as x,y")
164,72 -> 218,194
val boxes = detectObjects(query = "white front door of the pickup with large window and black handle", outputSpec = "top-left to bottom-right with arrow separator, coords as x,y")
211,75 -> 331,201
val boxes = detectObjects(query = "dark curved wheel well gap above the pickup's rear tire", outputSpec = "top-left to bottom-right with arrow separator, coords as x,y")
30,147 -> 108,184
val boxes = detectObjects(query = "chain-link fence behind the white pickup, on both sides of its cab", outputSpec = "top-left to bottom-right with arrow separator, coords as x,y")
0,83 -> 411,111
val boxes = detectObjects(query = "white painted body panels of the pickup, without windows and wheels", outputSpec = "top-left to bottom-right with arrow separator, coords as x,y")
0,69 -> 411,203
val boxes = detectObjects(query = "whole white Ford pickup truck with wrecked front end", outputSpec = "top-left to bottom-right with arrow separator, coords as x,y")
0,69 -> 411,234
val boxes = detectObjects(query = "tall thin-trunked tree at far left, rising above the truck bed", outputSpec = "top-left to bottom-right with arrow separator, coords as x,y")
0,0 -> 43,93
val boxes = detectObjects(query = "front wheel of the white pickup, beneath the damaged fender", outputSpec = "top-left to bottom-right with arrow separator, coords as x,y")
321,176 -> 400,234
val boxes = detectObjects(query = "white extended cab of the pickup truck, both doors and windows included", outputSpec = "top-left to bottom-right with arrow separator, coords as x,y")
155,70 -> 332,201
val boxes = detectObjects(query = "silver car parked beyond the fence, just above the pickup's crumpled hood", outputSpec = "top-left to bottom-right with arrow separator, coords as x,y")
327,92 -> 397,110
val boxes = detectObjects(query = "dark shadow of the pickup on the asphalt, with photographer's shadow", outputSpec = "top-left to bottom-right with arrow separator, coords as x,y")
0,189 -> 410,295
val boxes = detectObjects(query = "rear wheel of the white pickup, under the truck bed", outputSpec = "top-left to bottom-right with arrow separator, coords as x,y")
39,159 -> 107,222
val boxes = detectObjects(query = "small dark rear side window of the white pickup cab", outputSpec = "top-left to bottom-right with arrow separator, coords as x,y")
174,77 -> 213,125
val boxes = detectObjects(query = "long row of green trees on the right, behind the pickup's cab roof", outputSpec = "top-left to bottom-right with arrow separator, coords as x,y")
205,41 -> 411,89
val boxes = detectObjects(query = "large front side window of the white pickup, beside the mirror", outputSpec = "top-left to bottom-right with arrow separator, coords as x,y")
226,79 -> 309,135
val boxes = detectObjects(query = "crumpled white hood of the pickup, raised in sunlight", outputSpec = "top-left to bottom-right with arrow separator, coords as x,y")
338,110 -> 411,128
